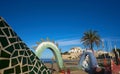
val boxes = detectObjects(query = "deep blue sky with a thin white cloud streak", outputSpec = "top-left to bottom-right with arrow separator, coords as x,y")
0,0 -> 120,58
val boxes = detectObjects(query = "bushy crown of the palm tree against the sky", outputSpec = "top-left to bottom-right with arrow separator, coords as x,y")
81,30 -> 102,50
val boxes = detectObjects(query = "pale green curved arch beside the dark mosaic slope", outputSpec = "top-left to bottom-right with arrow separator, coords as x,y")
35,41 -> 64,70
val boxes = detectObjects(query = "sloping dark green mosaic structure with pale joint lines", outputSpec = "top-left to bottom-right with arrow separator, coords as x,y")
0,17 -> 51,74
